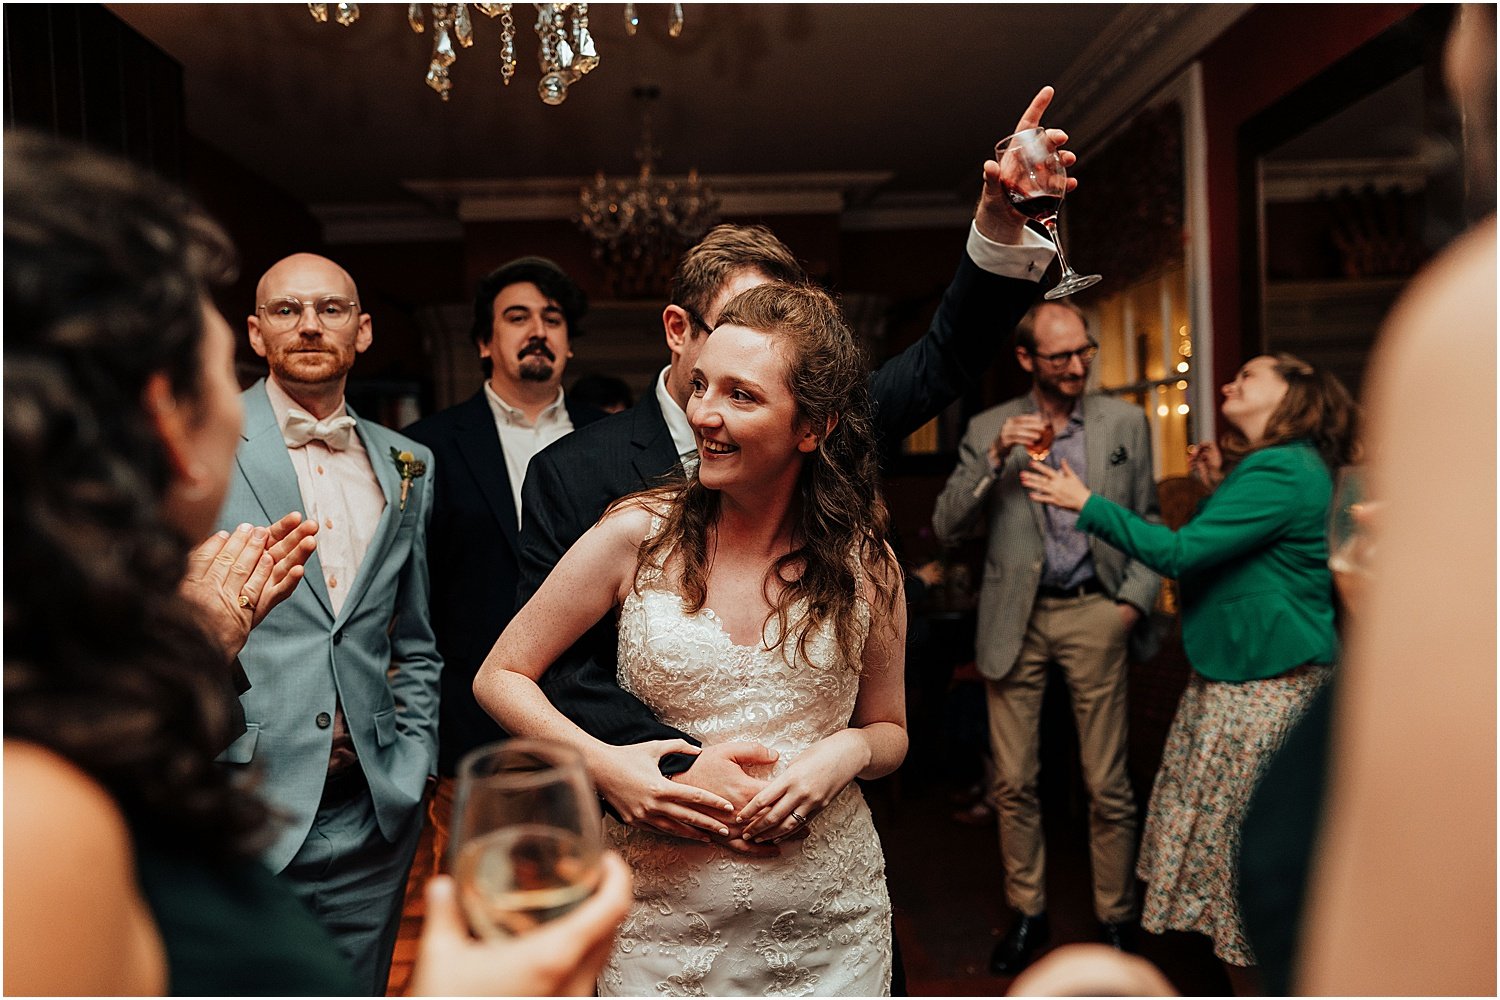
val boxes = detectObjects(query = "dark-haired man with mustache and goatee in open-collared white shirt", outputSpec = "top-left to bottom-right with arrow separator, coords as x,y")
405,256 -> 603,941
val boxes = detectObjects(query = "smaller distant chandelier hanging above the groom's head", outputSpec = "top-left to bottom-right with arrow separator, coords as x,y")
575,87 -> 719,298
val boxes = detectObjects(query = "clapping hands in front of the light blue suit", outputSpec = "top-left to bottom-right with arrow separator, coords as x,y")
182,511 -> 318,660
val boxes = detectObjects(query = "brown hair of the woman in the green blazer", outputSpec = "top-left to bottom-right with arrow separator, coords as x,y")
1220,351 -> 1359,469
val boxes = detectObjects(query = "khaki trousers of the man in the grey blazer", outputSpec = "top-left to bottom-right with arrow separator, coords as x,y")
986,594 -> 1136,924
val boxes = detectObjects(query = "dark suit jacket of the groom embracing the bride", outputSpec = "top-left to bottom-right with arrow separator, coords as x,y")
516,253 -> 1040,774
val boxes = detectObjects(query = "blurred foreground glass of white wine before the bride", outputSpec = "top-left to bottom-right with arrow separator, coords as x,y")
450,739 -> 603,937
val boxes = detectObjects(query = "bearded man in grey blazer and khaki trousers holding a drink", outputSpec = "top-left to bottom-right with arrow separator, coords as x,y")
933,301 -> 1161,976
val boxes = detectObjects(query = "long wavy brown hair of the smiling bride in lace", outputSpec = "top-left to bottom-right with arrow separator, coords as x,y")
621,282 -> 900,669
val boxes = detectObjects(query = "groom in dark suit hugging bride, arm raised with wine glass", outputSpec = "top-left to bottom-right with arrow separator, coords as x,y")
516,87 -> 1071,849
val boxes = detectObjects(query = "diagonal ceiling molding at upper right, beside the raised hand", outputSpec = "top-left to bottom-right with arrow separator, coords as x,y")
1047,3 -> 1256,147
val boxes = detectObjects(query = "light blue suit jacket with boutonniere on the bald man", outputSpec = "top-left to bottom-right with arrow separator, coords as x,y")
219,379 -> 443,871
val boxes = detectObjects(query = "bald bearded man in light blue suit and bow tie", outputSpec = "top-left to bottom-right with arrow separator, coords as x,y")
219,253 -> 443,996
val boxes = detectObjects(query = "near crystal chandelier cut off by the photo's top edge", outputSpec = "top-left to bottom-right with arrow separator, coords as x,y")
308,3 -> 683,105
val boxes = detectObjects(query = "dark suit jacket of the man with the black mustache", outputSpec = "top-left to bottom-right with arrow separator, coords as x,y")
404,388 -> 605,775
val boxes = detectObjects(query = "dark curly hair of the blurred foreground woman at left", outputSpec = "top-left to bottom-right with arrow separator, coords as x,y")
5,132 -> 267,855
